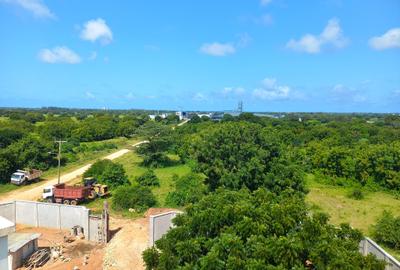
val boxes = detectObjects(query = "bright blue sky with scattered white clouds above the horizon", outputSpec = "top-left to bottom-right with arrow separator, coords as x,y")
0,0 -> 400,112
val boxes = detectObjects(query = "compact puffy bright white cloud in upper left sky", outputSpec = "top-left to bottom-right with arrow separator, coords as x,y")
81,18 -> 113,45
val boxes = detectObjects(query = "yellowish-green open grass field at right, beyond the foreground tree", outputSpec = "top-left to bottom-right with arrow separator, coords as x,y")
306,175 -> 400,260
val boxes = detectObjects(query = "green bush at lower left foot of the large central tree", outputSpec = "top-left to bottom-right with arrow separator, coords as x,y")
166,173 -> 207,206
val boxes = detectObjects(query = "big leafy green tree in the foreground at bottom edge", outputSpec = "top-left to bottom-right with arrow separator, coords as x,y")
145,189 -> 384,270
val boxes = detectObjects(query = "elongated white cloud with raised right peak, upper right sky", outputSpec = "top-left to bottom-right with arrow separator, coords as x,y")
286,18 -> 348,54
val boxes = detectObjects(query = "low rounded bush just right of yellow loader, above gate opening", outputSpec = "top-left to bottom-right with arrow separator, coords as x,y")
112,186 -> 156,212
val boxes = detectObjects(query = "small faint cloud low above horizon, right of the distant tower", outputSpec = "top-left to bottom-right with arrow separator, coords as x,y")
253,78 -> 292,100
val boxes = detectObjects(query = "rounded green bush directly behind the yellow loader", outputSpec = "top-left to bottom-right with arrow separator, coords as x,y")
83,159 -> 129,188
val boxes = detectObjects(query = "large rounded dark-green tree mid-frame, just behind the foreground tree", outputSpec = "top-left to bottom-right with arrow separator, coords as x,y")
185,122 -> 305,192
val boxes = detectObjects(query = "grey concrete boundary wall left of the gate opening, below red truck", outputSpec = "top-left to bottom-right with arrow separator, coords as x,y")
0,201 -> 107,242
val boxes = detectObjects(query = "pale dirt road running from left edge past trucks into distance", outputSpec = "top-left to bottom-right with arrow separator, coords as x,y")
0,141 -> 148,201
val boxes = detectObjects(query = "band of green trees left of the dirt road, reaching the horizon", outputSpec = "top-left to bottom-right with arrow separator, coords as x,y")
0,111 -> 149,183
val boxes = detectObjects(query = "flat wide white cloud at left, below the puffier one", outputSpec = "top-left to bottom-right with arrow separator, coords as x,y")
38,46 -> 81,64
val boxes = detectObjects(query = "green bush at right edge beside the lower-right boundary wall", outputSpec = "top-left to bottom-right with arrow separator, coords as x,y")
373,211 -> 400,249
